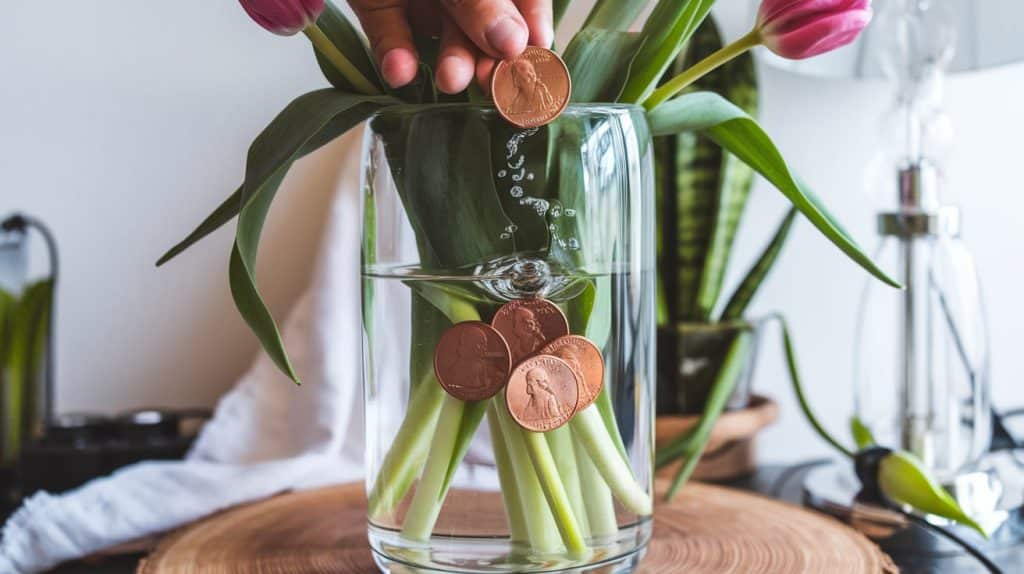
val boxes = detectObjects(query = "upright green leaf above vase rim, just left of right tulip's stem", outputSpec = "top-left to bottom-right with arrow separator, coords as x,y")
621,0 -> 715,103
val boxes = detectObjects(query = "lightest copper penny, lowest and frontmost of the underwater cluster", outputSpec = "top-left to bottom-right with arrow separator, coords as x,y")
505,355 -> 580,433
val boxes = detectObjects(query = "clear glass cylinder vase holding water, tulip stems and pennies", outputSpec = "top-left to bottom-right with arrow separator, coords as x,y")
362,104 -> 655,572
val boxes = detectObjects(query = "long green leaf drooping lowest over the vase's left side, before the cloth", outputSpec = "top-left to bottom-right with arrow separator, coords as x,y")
228,89 -> 388,383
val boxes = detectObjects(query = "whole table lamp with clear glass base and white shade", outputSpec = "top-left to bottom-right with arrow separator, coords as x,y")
753,0 -> 1024,553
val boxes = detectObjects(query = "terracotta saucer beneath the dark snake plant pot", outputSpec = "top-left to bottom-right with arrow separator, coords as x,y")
654,395 -> 778,481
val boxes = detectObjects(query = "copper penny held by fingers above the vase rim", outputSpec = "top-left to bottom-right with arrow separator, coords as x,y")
490,46 -> 572,128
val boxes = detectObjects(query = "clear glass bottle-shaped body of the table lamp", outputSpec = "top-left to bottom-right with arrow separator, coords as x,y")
854,218 -> 991,483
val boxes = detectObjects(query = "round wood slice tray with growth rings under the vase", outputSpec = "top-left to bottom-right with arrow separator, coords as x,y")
138,483 -> 895,574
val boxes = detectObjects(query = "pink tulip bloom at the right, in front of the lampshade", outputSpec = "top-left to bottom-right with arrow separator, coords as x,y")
755,0 -> 871,59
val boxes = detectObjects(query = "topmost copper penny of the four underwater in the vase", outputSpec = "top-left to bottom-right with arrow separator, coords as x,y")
490,299 -> 569,364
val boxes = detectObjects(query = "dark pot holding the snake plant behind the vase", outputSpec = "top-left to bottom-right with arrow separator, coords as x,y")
657,320 -> 763,416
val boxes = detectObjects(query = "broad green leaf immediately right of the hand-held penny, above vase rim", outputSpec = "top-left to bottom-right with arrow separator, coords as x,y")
563,28 -> 644,102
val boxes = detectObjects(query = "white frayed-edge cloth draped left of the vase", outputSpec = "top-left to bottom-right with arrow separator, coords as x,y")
0,130 -> 362,574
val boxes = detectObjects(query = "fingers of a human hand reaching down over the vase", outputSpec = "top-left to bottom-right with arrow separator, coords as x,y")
348,0 -> 554,93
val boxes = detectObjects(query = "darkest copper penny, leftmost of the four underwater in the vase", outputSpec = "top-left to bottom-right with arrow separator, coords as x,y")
434,321 -> 512,401
